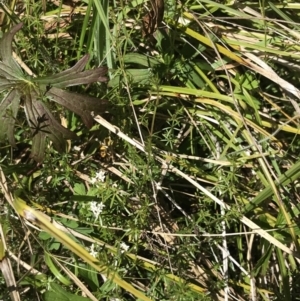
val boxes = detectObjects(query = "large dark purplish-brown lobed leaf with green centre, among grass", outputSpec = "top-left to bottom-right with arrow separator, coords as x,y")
0,23 -> 107,162
